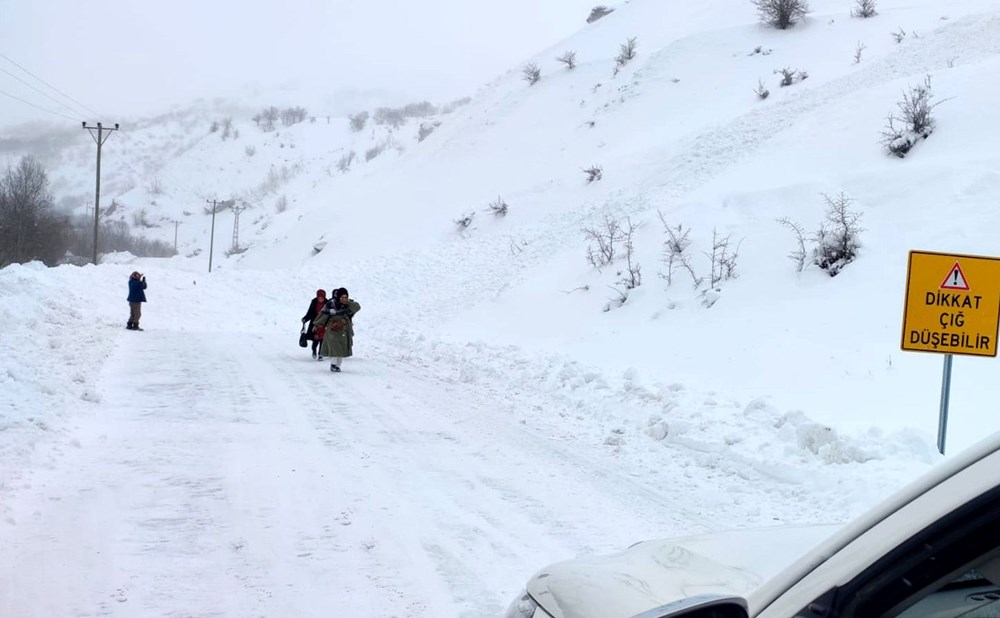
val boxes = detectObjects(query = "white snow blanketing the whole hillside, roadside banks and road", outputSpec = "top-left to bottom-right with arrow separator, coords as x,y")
0,0 -> 1000,618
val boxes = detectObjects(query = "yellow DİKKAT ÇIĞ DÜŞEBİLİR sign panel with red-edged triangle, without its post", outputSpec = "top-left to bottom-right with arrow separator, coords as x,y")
902,251 -> 1000,356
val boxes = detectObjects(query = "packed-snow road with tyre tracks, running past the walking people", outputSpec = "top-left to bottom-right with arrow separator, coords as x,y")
0,324 -> 740,617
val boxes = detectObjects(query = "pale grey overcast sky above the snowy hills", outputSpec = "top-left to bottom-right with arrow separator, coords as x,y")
0,0 -> 593,125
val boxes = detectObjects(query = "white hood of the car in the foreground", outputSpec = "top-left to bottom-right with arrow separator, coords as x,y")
527,525 -> 840,618
